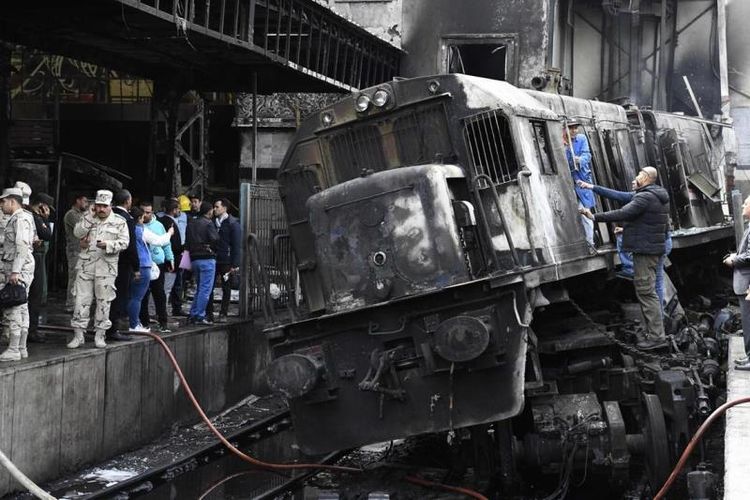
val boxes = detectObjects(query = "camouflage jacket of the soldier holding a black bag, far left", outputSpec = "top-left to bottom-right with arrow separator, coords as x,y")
3,210 -> 35,285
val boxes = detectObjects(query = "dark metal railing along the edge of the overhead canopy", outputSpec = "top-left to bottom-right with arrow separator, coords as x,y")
126,0 -> 400,90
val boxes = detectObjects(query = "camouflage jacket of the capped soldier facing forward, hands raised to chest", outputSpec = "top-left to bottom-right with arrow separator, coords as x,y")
73,212 -> 130,277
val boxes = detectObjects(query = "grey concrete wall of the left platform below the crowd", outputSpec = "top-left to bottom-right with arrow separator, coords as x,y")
0,321 -> 270,495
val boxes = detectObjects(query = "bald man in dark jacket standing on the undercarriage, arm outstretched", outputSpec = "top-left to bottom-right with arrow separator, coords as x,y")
582,167 -> 669,350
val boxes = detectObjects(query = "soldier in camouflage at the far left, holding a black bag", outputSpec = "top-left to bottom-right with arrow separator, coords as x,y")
0,188 -> 34,361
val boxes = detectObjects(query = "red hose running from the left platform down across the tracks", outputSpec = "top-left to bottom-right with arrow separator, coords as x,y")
135,332 -> 487,500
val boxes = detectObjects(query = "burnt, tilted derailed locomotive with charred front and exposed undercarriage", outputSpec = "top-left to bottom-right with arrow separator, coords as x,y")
265,75 -> 733,491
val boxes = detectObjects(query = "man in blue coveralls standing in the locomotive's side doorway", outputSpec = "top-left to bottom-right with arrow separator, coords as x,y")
563,122 -> 596,245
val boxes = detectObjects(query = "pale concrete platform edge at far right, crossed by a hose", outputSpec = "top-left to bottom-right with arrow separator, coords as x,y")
724,337 -> 750,500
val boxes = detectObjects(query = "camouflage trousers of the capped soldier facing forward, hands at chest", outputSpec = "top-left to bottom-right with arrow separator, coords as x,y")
70,269 -> 115,330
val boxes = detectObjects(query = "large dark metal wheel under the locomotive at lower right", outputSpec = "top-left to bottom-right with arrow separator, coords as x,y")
643,394 -> 672,491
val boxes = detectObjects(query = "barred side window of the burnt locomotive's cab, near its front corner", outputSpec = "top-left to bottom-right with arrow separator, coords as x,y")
464,110 -> 518,184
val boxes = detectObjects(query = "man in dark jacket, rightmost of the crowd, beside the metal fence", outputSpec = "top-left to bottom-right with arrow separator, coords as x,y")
206,198 -> 242,323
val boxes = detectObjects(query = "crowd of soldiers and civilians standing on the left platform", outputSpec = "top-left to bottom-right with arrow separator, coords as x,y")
0,182 -> 241,361
